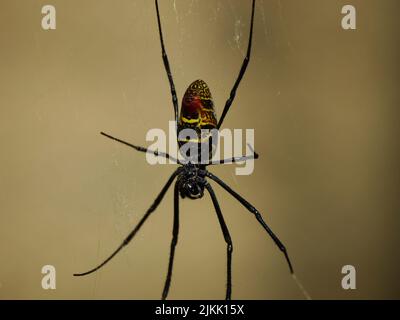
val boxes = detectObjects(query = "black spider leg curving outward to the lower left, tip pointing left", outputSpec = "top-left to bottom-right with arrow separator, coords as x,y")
74,168 -> 181,277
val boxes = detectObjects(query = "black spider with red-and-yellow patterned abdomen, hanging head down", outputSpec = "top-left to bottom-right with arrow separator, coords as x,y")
74,0 -> 293,300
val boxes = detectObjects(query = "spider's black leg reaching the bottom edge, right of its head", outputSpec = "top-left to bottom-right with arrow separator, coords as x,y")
205,183 -> 233,300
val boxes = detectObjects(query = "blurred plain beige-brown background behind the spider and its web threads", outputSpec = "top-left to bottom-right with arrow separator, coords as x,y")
0,0 -> 400,299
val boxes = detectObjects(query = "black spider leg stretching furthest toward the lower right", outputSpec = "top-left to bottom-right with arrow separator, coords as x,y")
206,171 -> 293,274
